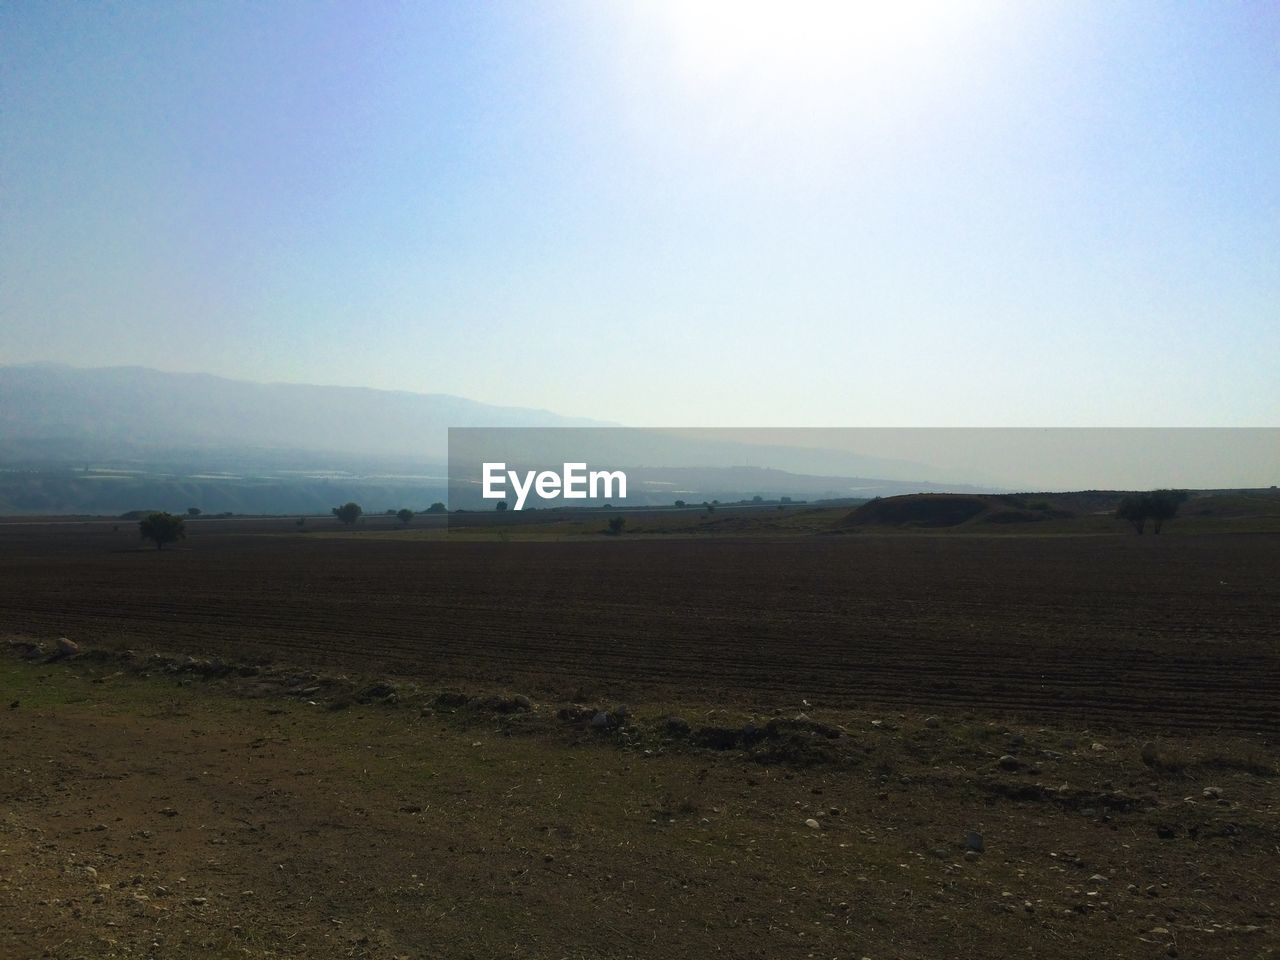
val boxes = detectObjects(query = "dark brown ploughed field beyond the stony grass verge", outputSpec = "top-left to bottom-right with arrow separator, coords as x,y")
0,521 -> 1280,733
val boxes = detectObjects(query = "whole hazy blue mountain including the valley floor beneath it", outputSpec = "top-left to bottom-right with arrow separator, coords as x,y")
0,364 -> 998,513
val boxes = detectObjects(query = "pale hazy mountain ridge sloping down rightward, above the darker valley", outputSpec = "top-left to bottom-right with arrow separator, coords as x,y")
0,364 -> 957,481
